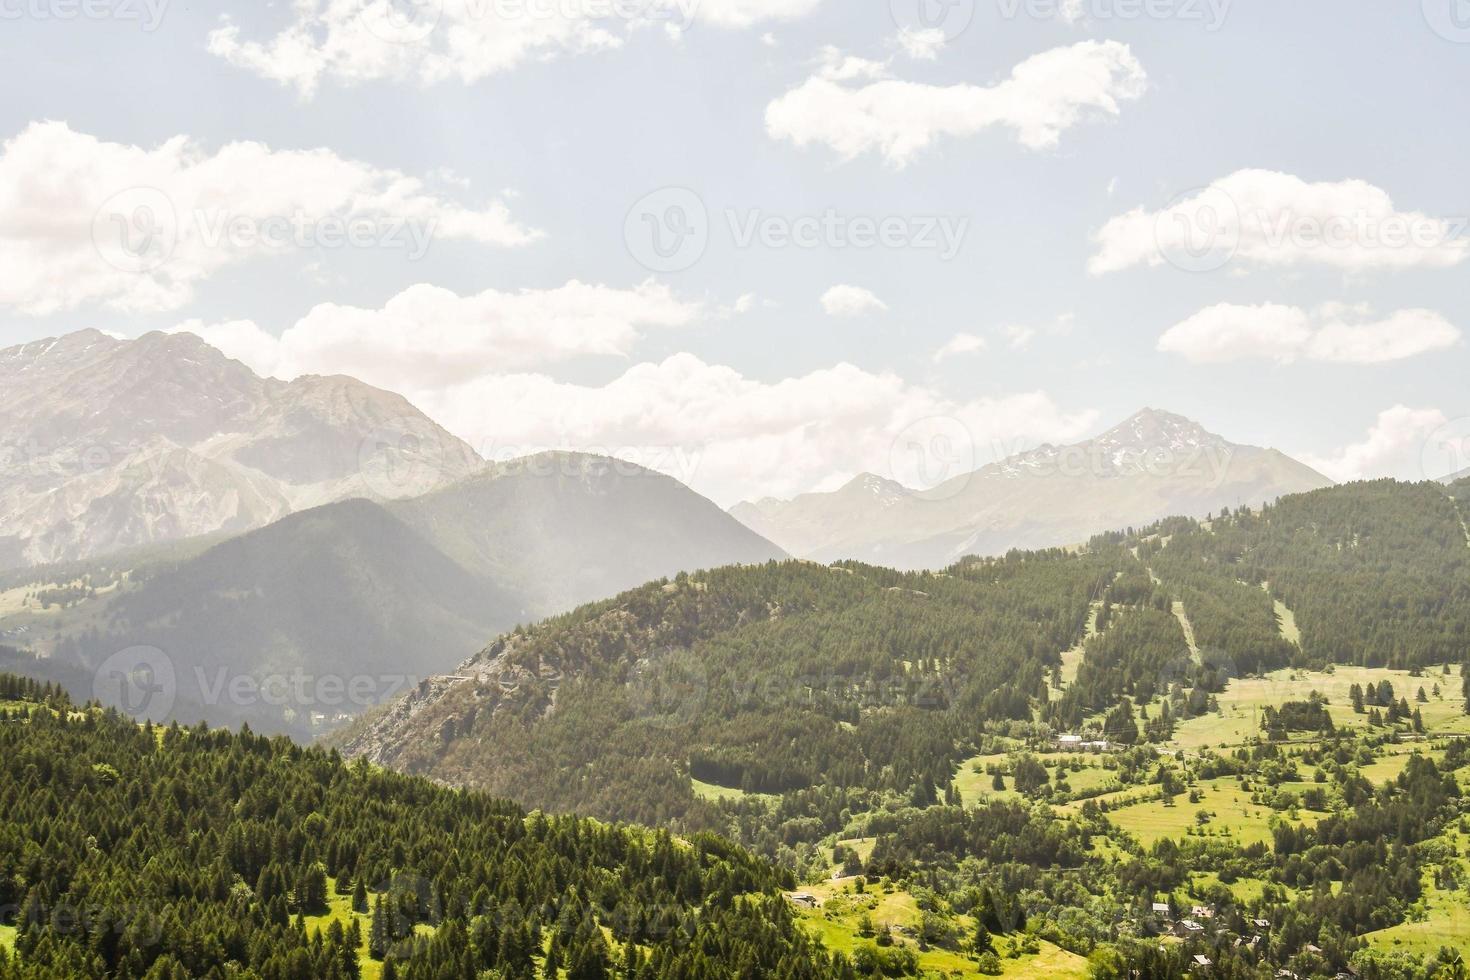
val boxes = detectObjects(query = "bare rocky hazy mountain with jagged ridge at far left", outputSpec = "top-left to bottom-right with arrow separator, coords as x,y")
0,331 -> 482,567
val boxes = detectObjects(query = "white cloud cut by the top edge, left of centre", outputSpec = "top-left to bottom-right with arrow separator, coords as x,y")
207,0 -> 820,98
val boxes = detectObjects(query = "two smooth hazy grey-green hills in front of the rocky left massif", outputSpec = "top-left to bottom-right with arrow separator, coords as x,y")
0,454 -> 785,736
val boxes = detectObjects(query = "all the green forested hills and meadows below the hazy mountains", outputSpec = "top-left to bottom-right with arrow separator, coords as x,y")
0,483 -> 1470,980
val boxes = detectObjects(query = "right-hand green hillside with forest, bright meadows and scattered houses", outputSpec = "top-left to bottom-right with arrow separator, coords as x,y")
330,483 -> 1470,980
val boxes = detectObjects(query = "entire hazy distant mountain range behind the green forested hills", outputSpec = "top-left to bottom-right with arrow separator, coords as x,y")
0,331 -> 1346,738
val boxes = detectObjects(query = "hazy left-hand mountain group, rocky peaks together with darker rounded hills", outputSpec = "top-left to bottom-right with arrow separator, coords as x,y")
0,331 -> 786,738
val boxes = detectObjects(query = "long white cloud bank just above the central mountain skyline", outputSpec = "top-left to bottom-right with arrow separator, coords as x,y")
171,299 -> 1098,504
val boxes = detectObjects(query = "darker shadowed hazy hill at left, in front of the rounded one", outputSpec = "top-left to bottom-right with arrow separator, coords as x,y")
4,500 -> 520,736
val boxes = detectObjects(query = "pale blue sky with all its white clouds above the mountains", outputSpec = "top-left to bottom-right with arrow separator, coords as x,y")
0,0 -> 1470,505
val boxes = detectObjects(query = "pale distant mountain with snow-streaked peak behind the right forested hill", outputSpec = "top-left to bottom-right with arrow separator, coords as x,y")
731,408 -> 1332,569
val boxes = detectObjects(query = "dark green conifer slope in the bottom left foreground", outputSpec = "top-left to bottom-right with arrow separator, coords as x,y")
0,676 -> 856,980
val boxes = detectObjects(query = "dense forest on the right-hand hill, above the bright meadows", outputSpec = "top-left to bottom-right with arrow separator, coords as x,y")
341,483 -> 1470,827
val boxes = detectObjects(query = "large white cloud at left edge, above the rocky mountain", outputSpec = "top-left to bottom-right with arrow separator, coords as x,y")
0,122 -> 537,314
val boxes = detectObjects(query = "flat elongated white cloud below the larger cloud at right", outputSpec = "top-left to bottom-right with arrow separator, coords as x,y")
1158,303 -> 1461,364
